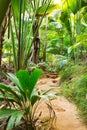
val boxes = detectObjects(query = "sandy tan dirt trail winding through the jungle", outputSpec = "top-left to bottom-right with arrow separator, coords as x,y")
37,74 -> 87,130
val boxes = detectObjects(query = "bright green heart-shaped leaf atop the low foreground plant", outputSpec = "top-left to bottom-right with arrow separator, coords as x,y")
17,69 -> 42,97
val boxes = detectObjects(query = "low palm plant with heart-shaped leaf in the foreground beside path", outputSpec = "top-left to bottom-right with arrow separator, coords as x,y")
0,69 -> 56,130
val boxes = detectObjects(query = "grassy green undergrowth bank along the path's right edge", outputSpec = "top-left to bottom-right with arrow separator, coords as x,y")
61,65 -> 87,122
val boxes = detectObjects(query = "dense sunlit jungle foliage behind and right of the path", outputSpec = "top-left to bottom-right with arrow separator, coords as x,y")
0,0 -> 87,127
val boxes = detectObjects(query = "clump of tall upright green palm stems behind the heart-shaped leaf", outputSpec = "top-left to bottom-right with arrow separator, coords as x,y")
11,0 -> 55,71
